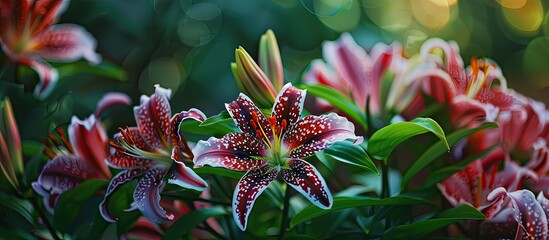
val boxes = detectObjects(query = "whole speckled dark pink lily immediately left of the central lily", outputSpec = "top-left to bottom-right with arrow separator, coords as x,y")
99,85 -> 208,223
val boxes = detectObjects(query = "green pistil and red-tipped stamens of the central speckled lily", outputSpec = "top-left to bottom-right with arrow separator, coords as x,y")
250,111 -> 288,166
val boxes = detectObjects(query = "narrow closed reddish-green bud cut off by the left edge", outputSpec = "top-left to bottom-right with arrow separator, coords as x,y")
0,98 -> 23,189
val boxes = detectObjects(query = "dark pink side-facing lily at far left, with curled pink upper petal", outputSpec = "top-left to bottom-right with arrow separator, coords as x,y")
31,93 -> 131,213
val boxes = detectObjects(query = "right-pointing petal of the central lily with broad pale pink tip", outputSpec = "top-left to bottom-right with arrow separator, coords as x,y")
283,113 -> 357,158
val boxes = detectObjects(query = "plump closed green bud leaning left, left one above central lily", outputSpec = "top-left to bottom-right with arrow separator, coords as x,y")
231,47 -> 278,107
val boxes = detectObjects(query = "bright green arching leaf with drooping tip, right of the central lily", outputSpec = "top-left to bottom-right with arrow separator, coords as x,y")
368,118 -> 450,161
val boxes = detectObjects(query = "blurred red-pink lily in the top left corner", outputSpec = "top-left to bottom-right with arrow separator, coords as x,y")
0,0 -> 101,98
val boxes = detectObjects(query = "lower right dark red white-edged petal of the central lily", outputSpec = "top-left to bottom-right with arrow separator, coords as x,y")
280,159 -> 334,209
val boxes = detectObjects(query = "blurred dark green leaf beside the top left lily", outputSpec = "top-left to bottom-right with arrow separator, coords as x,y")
57,61 -> 128,81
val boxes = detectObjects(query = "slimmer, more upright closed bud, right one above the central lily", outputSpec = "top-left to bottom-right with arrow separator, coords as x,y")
259,29 -> 284,91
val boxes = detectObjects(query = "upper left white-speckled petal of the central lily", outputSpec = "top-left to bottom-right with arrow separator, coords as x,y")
225,93 -> 272,139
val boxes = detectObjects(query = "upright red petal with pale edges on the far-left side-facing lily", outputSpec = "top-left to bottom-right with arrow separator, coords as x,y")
68,115 -> 111,177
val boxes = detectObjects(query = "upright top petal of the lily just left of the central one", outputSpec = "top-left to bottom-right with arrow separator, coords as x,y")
133,85 -> 171,148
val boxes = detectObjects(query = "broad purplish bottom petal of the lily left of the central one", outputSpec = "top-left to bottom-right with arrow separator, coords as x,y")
133,168 -> 174,223
